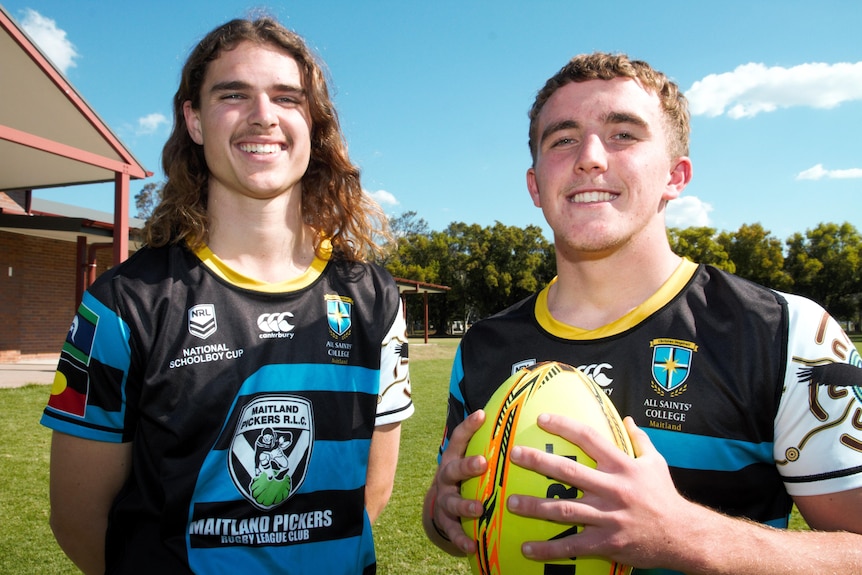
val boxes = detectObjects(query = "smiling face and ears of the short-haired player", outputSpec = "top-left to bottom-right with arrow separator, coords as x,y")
527,78 -> 691,257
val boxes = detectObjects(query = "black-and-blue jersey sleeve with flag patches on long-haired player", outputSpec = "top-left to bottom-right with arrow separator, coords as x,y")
41,283 -> 131,443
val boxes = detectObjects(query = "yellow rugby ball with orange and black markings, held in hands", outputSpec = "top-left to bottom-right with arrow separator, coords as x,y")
461,362 -> 634,575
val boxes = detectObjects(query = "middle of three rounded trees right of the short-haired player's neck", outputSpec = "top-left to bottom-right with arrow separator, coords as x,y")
717,223 -> 793,291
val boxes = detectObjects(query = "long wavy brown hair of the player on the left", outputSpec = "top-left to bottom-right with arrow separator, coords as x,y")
144,17 -> 387,261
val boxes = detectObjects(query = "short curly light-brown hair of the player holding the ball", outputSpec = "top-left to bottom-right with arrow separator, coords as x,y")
528,52 -> 691,165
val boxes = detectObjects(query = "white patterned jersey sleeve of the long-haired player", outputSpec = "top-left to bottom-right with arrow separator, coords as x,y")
375,299 -> 414,426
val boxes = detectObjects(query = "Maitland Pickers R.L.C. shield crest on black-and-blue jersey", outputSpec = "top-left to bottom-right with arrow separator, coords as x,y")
228,395 -> 314,510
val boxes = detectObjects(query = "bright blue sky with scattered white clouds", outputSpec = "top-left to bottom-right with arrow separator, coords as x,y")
0,0 -> 862,240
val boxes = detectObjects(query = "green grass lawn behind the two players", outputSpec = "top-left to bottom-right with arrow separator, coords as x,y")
5,336 -> 862,575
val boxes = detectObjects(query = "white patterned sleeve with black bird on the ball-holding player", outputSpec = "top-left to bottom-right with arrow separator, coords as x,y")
773,295 -> 862,496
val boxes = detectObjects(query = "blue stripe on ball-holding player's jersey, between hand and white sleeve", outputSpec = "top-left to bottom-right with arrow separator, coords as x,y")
643,427 -> 775,471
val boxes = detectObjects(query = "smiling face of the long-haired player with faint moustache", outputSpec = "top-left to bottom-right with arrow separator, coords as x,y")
183,42 -> 311,204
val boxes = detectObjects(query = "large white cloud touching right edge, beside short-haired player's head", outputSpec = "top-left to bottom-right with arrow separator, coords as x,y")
685,62 -> 862,119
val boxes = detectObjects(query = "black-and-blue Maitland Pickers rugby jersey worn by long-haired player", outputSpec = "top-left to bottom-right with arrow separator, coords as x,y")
42,242 -> 413,574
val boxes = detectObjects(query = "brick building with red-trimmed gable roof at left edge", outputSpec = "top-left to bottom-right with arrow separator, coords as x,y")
0,6 -> 152,362
